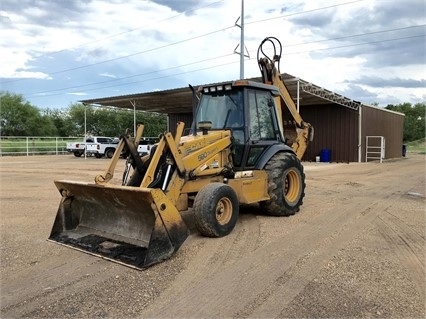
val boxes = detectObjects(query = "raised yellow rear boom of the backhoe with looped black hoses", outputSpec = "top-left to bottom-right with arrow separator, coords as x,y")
257,37 -> 313,159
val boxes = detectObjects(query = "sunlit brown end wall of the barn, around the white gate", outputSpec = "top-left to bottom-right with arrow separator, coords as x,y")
361,106 -> 404,162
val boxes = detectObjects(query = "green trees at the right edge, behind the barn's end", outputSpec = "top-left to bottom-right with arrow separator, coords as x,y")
386,102 -> 426,142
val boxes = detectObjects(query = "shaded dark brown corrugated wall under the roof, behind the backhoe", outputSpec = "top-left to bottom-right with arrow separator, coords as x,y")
300,104 -> 359,163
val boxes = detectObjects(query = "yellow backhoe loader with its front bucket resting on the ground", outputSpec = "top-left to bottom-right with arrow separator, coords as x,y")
49,38 -> 313,269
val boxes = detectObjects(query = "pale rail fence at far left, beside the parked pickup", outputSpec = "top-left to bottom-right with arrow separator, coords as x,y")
0,136 -> 83,156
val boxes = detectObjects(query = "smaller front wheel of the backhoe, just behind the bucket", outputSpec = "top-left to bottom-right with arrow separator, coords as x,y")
193,183 -> 239,237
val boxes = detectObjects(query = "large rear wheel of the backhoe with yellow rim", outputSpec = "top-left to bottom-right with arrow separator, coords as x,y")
260,153 -> 306,216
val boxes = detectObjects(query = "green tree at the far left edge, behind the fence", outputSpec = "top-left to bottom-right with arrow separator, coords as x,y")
0,92 -> 57,136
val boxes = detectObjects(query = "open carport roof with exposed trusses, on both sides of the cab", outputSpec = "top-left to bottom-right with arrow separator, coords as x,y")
80,73 -> 361,114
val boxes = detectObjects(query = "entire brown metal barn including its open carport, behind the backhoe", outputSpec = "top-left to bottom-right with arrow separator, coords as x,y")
81,73 -> 404,163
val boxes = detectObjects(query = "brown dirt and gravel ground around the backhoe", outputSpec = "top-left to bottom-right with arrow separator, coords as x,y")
0,154 -> 426,318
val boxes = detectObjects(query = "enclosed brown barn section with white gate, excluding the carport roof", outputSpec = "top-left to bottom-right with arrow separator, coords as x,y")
294,103 -> 404,162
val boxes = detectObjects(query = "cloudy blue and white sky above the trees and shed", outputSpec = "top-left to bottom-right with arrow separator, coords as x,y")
0,0 -> 426,109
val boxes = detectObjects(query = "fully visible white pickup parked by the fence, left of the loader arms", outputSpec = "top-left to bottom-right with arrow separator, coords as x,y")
67,136 -> 119,158
